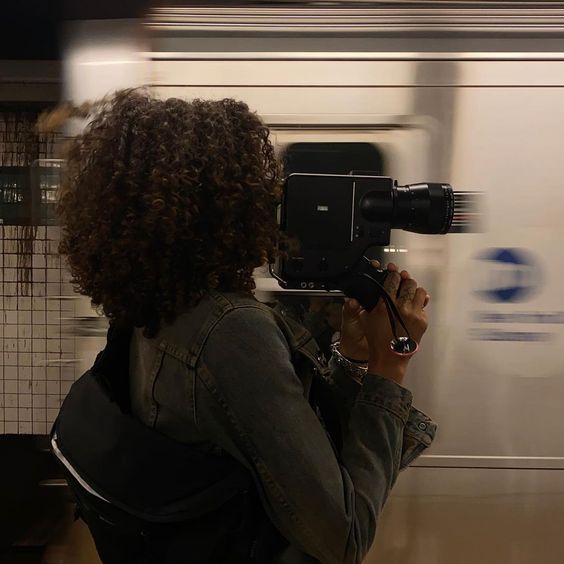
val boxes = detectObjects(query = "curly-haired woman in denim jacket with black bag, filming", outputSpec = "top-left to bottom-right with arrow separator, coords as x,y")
50,91 -> 435,564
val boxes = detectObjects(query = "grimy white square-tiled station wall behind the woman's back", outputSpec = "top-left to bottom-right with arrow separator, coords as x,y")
0,226 -> 77,434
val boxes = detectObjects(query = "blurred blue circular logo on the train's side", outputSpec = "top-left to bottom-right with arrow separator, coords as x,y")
476,248 -> 541,302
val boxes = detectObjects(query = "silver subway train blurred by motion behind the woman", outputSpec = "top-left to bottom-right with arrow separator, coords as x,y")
3,0 -> 564,564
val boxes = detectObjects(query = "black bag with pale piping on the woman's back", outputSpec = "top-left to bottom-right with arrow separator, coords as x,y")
51,328 -> 280,564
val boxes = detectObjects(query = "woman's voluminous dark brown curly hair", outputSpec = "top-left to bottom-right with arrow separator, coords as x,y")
58,90 -> 281,337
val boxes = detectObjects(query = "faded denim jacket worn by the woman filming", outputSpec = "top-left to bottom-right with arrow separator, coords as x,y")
130,292 -> 436,564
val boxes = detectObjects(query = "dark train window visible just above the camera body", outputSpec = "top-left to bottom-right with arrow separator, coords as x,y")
283,143 -> 383,175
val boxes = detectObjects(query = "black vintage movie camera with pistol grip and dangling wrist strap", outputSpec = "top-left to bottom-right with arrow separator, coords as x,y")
270,171 -> 469,354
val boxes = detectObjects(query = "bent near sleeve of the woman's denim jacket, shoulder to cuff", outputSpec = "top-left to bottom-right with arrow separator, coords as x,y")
195,307 -> 411,564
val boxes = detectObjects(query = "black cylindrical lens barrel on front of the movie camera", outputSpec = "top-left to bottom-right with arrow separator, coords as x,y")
392,183 -> 455,234
